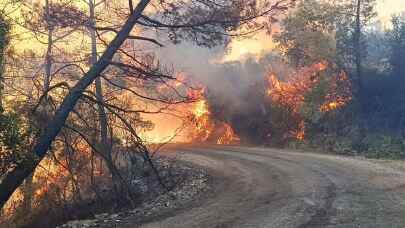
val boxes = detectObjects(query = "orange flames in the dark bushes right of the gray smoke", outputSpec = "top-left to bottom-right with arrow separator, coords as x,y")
267,61 -> 352,141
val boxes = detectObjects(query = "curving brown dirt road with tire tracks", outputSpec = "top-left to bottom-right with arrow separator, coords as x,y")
137,147 -> 405,228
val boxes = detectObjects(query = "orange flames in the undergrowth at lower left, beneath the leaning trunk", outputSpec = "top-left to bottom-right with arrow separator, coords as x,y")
2,142 -> 102,220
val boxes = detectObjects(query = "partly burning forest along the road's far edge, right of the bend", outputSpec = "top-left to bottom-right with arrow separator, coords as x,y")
200,0 -> 405,158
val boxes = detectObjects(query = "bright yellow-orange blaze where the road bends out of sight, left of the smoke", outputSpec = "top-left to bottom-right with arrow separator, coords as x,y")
141,82 -> 240,144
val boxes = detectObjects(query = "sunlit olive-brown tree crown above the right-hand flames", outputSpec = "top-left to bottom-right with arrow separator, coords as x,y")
275,0 -> 339,66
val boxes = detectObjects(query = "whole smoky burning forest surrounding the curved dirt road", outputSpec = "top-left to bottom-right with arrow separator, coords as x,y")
0,0 -> 405,227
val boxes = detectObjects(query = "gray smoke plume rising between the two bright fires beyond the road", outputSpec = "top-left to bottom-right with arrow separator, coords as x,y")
154,41 -> 289,143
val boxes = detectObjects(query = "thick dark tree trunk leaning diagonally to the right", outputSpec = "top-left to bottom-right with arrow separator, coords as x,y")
0,0 -> 150,207
